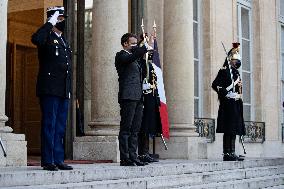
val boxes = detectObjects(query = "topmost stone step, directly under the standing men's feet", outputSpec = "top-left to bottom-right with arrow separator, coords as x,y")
0,158 -> 284,186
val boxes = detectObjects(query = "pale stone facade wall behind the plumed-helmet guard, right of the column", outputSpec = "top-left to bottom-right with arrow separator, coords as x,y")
202,0 -> 284,158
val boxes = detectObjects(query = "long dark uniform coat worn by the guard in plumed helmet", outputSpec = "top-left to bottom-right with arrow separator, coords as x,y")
212,63 -> 245,135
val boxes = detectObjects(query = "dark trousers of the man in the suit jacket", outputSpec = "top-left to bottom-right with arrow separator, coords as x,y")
118,100 -> 143,160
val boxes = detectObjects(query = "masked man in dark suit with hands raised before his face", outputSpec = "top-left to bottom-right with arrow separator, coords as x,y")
115,33 -> 151,166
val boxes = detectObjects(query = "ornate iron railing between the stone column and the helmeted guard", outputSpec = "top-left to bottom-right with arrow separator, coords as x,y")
194,118 -> 215,143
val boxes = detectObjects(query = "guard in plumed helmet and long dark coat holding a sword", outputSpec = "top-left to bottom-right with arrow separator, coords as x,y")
212,43 -> 245,161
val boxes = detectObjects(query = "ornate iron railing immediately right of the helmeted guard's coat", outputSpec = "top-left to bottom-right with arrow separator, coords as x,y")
243,121 -> 265,143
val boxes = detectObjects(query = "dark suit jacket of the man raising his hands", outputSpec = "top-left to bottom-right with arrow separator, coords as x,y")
115,46 -> 147,102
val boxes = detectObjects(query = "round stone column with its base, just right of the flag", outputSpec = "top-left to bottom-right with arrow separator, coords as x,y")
157,0 -> 206,159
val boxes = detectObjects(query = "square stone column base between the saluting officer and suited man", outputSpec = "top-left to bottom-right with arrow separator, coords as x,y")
73,136 -> 120,162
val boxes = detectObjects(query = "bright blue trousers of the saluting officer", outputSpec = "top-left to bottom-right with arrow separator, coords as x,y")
40,96 -> 69,166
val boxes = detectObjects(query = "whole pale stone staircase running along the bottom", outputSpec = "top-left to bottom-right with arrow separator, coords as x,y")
0,158 -> 284,189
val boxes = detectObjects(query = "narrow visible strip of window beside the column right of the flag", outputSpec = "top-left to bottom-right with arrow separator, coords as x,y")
193,0 -> 202,117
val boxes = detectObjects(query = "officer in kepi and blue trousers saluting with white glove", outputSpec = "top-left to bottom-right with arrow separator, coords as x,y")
32,7 -> 73,171
